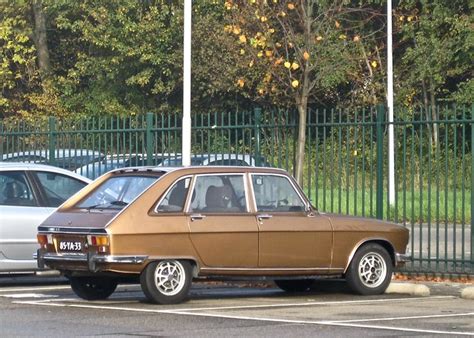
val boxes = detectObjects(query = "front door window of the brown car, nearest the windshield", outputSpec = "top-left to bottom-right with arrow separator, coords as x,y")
252,175 -> 305,212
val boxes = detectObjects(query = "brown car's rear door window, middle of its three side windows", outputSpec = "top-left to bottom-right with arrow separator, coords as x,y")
191,175 -> 247,213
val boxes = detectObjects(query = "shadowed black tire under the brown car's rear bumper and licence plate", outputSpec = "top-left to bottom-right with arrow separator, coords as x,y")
69,277 -> 117,300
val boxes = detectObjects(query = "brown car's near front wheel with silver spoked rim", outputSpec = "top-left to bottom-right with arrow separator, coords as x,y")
346,243 -> 393,295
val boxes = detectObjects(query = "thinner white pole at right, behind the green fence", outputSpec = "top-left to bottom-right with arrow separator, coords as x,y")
387,0 -> 395,205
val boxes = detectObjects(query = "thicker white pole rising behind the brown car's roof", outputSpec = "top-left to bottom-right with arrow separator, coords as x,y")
181,0 -> 192,167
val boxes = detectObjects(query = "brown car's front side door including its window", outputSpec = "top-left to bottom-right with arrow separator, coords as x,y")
251,174 -> 332,269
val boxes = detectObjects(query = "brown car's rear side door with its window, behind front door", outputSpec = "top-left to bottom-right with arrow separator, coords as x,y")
188,174 -> 258,270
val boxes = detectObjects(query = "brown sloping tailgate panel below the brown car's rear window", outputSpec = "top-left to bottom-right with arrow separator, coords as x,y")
40,210 -> 119,230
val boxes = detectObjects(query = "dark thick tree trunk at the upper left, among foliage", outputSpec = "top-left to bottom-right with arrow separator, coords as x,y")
32,0 -> 51,79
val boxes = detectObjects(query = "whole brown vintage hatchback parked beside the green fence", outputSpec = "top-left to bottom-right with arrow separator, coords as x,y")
37,167 -> 408,304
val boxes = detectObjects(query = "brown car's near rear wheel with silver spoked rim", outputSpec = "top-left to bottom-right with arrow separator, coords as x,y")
140,260 -> 192,304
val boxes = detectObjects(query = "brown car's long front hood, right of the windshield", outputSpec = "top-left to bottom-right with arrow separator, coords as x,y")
321,213 -> 406,232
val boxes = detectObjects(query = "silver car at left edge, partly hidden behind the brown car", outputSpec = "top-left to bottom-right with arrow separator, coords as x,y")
0,162 -> 91,273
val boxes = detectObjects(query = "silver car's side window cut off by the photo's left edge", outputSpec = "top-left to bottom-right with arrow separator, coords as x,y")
0,171 -> 37,207
